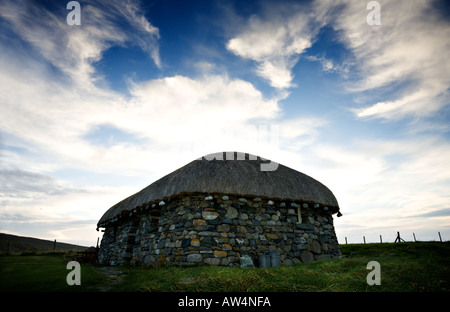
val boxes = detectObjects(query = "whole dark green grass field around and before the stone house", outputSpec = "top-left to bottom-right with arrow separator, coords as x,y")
0,242 -> 450,292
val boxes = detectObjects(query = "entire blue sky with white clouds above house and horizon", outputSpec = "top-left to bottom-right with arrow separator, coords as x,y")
0,0 -> 450,246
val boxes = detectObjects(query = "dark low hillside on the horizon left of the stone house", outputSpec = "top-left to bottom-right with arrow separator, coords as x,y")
0,233 -> 88,254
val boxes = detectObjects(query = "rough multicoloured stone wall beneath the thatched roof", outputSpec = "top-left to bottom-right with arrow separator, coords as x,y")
99,194 -> 341,266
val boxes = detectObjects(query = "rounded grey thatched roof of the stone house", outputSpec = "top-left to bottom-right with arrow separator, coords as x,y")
98,152 -> 339,226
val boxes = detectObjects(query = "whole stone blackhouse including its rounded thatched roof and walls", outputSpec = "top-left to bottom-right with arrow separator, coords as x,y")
97,152 -> 341,266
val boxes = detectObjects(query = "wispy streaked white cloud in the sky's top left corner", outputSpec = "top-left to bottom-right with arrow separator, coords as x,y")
0,1 -> 161,91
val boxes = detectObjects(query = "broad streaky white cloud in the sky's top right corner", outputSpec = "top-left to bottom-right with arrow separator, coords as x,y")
315,0 -> 450,119
